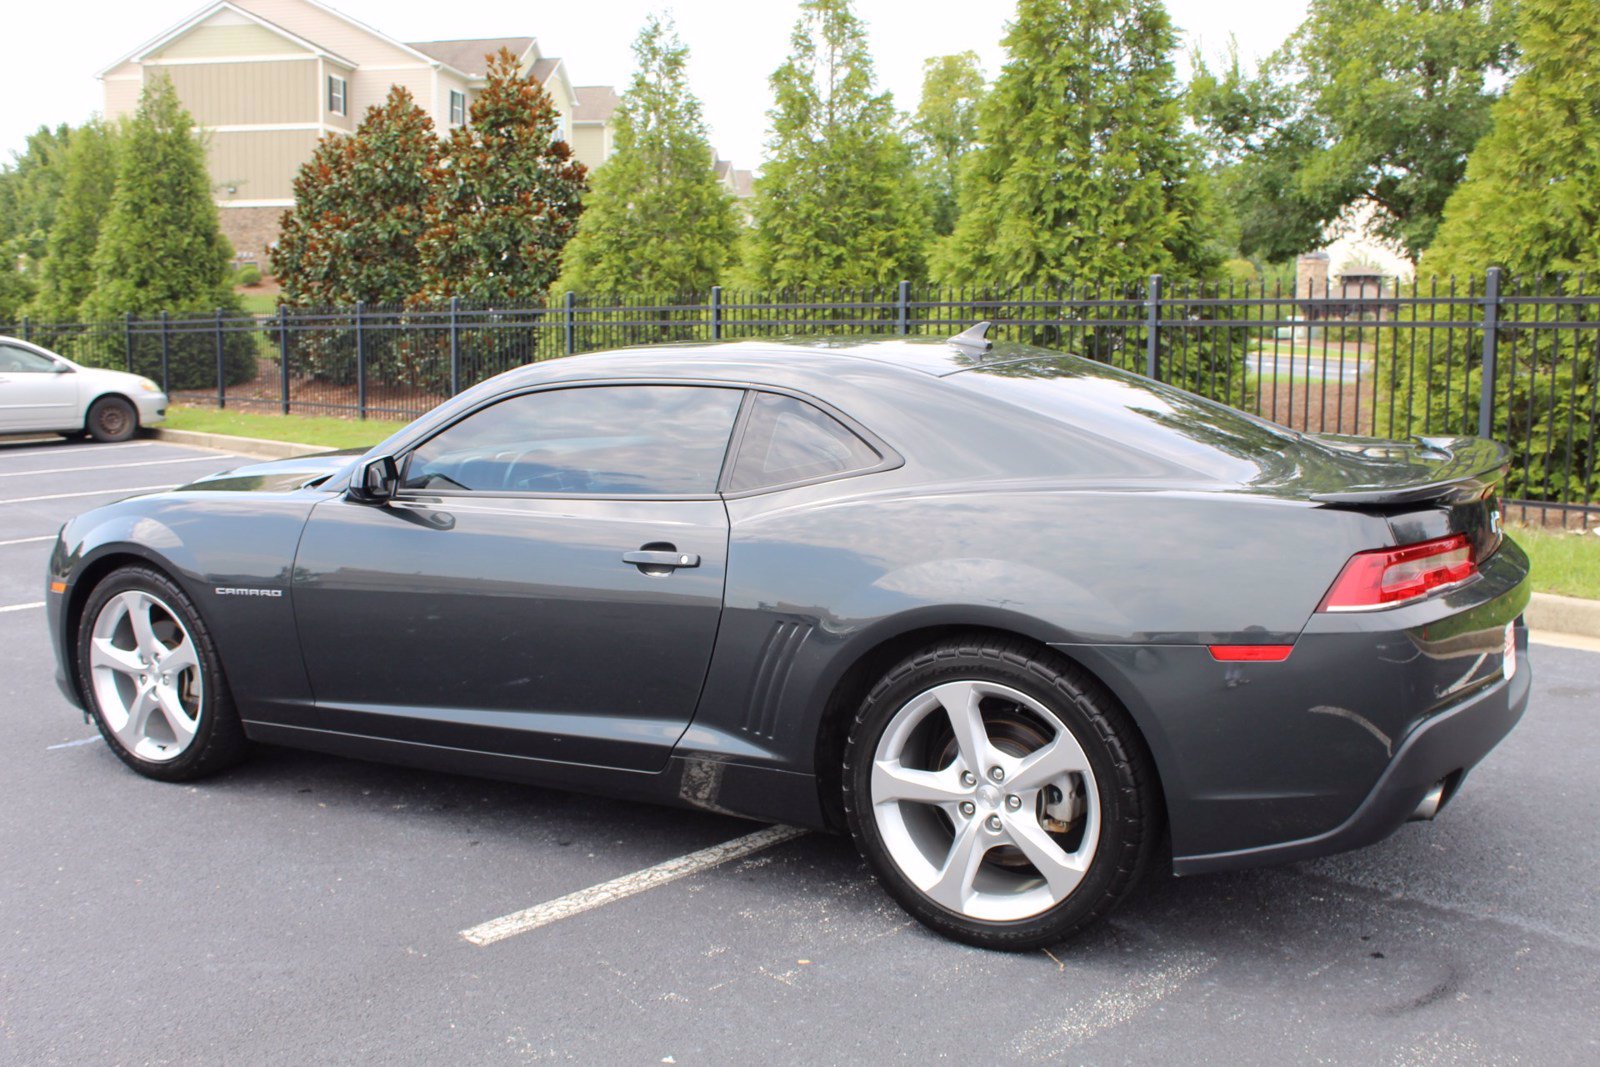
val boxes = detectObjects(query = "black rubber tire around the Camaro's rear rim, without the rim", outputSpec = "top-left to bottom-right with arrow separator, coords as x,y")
843,637 -> 1163,952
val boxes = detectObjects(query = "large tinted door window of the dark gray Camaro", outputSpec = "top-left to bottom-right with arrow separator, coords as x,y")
402,386 -> 744,496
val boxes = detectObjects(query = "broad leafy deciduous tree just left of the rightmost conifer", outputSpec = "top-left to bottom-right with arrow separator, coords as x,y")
1194,0 -> 1514,261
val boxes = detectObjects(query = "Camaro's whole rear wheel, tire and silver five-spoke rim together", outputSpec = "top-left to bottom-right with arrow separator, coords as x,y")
843,640 -> 1160,950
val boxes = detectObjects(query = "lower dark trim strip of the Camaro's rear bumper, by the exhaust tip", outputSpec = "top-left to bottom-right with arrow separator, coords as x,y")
1173,627 -> 1533,875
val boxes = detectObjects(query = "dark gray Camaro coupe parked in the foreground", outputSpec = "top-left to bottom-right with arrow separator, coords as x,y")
50,333 -> 1530,949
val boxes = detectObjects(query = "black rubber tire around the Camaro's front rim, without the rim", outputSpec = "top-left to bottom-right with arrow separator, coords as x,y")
77,566 -> 250,782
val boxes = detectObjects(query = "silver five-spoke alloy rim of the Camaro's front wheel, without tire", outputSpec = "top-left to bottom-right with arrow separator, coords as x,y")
90,589 -> 205,763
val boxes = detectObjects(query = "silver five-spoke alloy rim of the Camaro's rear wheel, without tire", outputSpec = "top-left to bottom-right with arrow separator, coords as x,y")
870,680 -> 1101,921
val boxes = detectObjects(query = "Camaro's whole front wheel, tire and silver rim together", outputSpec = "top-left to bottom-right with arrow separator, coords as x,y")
77,566 -> 246,782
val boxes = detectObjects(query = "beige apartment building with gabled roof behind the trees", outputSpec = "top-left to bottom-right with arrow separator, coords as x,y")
99,0 -> 616,267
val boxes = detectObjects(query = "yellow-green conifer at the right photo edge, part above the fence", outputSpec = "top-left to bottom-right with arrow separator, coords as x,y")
1422,0 -> 1600,274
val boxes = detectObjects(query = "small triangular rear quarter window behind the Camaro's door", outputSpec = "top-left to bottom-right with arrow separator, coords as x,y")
728,394 -> 882,493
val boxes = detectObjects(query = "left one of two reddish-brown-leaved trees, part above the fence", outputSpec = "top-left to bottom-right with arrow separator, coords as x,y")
272,85 -> 440,307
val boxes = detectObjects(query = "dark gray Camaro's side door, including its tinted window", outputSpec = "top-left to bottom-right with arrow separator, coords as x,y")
293,384 -> 744,769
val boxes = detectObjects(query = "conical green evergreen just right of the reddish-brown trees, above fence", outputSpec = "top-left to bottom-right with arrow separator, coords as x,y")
555,16 -> 739,293
